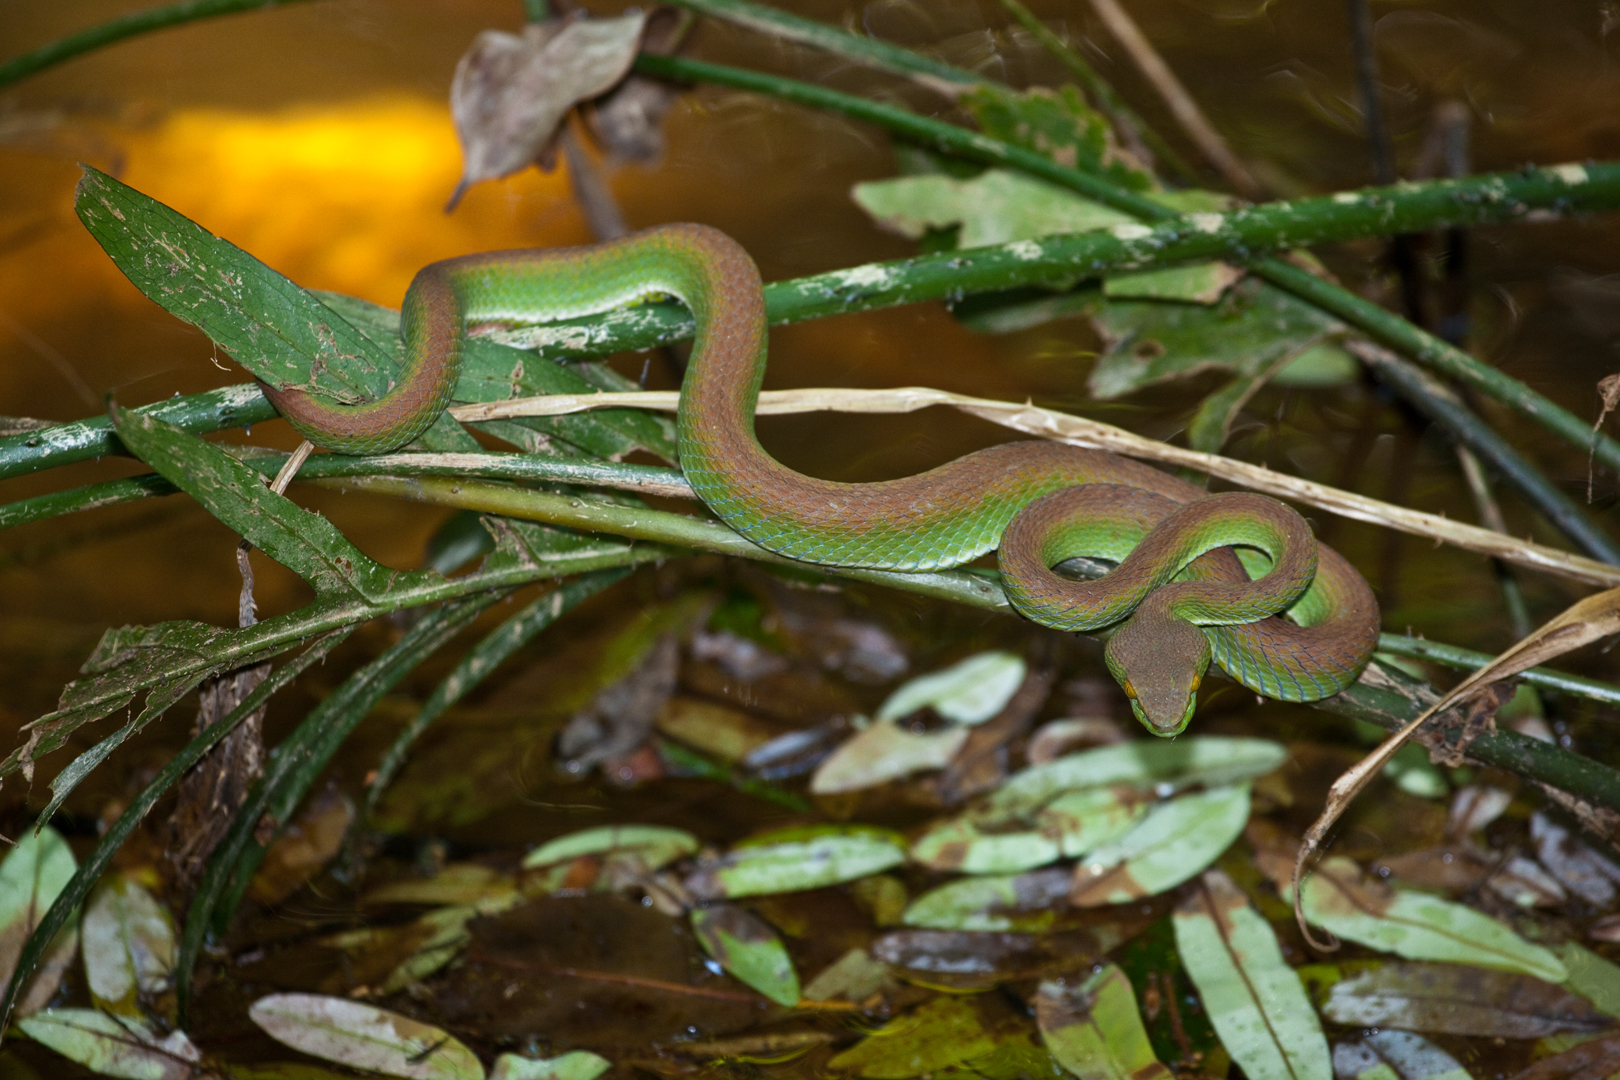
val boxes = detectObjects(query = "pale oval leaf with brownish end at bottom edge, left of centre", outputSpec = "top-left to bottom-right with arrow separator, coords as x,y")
248,994 -> 484,1080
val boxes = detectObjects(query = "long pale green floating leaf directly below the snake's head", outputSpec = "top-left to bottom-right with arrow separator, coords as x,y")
980,735 -> 1288,821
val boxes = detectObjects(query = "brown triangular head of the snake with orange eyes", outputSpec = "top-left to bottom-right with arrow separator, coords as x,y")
1103,606 -> 1210,738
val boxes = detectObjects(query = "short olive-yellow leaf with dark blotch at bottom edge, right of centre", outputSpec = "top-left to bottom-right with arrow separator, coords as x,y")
1035,963 -> 1171,1080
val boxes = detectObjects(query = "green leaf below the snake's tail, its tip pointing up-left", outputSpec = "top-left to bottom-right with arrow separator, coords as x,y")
112,399 -> 424,601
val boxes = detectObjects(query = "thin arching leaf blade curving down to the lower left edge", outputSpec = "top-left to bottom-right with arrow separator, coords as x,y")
0,627 -> 353,1031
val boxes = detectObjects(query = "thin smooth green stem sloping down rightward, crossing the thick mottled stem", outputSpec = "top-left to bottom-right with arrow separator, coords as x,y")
637,48 -> 1620,470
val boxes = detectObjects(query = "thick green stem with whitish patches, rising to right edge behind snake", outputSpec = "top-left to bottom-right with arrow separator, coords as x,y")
12,162 -> 1620,479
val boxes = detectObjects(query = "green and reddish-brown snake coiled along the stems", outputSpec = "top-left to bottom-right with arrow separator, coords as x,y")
264,225 -> 1379,735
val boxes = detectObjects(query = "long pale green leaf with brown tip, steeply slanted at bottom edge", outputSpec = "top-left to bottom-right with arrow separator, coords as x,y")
1175,870 -> 1333,1080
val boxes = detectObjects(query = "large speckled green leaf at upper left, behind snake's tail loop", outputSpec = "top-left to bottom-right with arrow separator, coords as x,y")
75,168 -> 397,403
